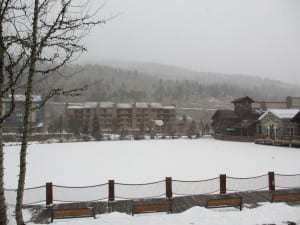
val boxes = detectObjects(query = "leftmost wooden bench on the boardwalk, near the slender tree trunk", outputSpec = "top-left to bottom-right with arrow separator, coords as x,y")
51,207 -> 96,223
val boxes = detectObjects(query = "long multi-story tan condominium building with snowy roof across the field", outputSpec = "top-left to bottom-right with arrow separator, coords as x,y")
66,102 -> 176,133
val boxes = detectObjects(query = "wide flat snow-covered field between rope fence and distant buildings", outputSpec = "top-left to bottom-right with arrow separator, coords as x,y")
5,138 -> 300,188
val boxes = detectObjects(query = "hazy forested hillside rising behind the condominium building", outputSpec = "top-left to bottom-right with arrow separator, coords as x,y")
41,64 -> 300,107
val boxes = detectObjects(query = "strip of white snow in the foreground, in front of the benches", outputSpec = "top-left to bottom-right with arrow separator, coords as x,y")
9,203 -> 300,225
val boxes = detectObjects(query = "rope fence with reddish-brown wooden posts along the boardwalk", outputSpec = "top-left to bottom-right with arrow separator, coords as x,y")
5,172 -> 300,205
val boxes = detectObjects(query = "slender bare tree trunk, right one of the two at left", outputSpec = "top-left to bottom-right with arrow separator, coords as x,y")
15,0 -> 39,225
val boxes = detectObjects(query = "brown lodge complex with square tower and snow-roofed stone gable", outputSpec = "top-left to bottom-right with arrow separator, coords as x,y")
212,96 -> 300,139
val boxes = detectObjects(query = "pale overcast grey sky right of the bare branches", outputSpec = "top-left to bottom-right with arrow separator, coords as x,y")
82,0 -> 300,84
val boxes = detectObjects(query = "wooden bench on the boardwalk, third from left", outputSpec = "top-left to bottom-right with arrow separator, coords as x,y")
206,197 -> 243,210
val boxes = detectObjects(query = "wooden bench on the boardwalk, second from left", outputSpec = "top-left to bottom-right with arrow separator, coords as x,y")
132,202 -> 173,215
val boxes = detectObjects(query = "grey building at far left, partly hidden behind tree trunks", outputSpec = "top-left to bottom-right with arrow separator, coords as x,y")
3,95 -> 43,133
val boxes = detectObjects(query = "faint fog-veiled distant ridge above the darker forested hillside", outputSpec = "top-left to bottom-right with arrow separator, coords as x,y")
100,61 -> 300,94
